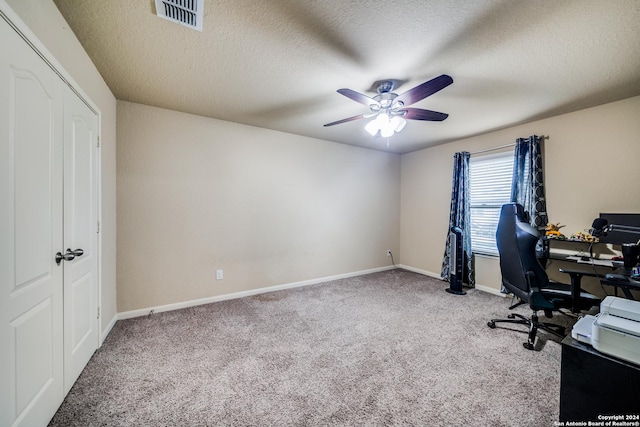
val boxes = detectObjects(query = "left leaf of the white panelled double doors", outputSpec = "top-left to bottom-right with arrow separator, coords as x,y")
0,14 -> 64,426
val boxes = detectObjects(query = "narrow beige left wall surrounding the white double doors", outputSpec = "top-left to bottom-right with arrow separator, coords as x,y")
7,0 -> 116,333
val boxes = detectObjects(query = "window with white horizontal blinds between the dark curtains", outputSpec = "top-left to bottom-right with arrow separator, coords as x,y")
469,151 -> 513,255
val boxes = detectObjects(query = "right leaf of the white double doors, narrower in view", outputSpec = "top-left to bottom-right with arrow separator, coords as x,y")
63,87 -> 98,394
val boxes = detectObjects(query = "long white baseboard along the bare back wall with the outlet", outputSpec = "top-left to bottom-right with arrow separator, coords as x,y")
115,265 -> 400,320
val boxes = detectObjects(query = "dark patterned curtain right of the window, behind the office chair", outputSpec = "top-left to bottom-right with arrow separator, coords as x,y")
511,135 -> 548,230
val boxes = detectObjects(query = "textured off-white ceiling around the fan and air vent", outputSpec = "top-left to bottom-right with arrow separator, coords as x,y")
54,0 -> 640,153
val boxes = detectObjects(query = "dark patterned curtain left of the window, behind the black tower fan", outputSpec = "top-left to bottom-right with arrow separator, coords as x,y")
440,151 -> 475,286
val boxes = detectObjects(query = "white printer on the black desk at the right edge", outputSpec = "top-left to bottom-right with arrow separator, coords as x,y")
571,296 -> 640,365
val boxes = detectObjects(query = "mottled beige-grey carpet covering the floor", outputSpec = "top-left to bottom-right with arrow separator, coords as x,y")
50,270 -> 570,427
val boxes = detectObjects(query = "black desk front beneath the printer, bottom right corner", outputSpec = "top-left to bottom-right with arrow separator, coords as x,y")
560,335 -> 640,423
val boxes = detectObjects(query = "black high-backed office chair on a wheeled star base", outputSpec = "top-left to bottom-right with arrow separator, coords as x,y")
487,203 -> 600,350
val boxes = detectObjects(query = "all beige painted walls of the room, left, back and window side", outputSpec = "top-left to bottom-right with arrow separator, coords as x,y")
7,0 -> 640,318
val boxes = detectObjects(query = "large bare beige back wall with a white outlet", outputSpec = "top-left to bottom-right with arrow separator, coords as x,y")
117,101 -> 400,312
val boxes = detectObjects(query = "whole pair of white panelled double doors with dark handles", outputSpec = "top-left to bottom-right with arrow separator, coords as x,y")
0,11 -> 99,427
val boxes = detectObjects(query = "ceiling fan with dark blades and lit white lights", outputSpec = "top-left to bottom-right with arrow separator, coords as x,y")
324,74 -> 453,137
